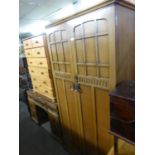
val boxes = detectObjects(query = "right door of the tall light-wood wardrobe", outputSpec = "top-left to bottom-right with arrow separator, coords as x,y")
73,6 -> 113,155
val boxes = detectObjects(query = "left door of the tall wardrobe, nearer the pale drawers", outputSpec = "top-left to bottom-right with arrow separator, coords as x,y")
49,26 -> 81,153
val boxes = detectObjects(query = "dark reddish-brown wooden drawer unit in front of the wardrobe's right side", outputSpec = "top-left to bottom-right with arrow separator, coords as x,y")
110,81 -> 135,143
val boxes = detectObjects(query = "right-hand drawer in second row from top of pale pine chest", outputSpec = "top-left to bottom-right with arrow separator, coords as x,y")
32,47 -> 46,58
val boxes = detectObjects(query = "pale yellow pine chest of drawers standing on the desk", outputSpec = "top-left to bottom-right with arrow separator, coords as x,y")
23,34 -> 55,101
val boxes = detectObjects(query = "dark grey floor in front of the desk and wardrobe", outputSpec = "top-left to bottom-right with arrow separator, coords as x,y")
19,102 -> 69,155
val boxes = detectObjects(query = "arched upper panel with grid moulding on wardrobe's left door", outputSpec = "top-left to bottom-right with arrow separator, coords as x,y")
49,30 -> 71,73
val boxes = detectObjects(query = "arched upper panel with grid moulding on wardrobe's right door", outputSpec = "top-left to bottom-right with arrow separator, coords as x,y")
74,18 -> 109,78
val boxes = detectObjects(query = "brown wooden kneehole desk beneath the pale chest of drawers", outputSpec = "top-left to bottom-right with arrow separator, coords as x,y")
27,90 -> 62,139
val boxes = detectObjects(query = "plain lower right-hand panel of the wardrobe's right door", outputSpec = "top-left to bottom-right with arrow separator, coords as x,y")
95,88 -> 113,154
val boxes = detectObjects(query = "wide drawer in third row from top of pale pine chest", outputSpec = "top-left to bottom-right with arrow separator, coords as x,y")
27,58 -> 48,67
